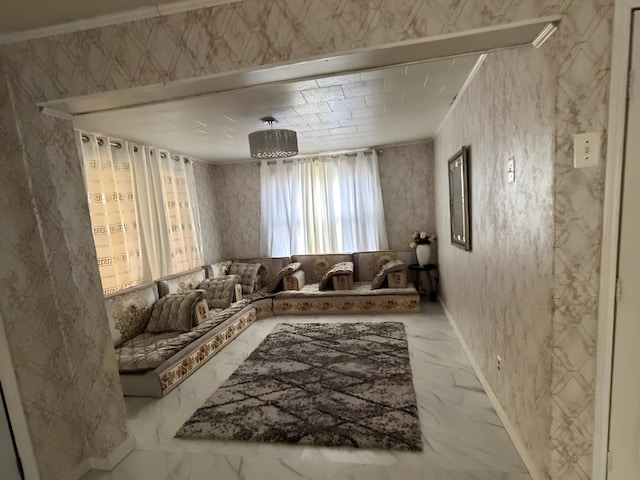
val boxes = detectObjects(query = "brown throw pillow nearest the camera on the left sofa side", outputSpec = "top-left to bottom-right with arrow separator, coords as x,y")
145,290 -> 202,333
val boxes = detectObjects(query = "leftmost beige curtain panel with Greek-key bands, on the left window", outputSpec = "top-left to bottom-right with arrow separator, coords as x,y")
79,134 -> 143,295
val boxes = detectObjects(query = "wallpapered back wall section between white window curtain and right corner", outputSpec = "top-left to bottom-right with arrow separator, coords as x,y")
378,142 -> 436,250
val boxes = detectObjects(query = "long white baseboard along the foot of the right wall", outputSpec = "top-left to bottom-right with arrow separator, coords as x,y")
438,297 -> 548,480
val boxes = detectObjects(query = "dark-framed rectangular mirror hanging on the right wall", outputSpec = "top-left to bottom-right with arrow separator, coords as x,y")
449,147 -> 471,250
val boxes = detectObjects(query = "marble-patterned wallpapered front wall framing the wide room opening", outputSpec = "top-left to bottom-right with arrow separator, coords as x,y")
0,0 -> 613,480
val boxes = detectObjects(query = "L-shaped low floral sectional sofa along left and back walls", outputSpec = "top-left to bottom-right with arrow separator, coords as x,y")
105,250 -> 420,397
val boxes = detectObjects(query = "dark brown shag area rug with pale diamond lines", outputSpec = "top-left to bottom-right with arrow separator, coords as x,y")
176,322 -> 422,450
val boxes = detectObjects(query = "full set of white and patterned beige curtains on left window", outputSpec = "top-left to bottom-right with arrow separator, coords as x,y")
79,132 -> 201,294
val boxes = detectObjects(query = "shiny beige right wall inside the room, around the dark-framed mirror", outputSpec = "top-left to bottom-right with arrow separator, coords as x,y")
435,47 -> 556,477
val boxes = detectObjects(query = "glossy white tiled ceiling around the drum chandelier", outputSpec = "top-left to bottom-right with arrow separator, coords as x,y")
74,55 -> 480,162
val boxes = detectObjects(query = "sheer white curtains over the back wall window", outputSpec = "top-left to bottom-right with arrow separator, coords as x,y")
260,151 -> 388,256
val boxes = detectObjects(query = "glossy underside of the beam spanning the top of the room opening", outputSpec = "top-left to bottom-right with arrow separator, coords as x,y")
37,15 -> 561,115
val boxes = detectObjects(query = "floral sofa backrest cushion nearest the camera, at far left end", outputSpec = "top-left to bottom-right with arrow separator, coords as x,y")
104,283 -> 160,347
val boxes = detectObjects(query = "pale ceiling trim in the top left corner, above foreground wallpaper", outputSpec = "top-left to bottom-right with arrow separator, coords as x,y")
0,0 -> 242,45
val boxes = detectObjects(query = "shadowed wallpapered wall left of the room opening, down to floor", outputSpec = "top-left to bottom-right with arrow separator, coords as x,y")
0,66 -> 127,480
